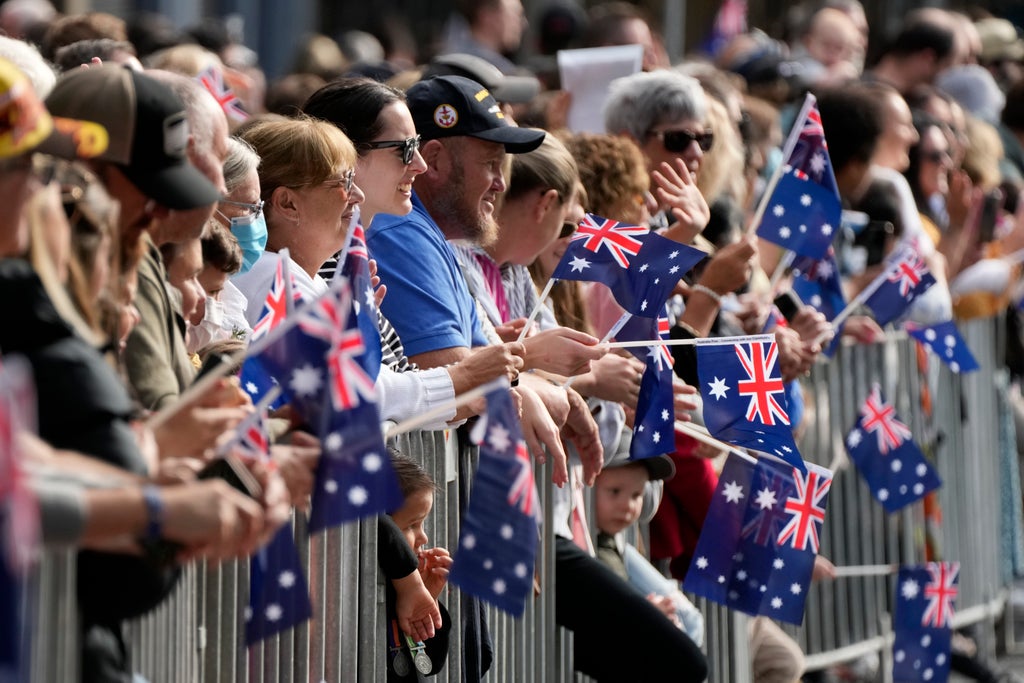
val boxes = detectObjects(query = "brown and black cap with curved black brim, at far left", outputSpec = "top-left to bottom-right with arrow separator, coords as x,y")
46,65 -> 220,210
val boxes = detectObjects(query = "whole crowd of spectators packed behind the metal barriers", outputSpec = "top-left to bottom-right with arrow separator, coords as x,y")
6,0 -> 1024,683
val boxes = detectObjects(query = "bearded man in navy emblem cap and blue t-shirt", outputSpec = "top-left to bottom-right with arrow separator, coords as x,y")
367,76 -> 544,368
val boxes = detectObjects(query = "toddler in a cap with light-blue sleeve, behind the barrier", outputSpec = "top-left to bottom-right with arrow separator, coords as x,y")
594,450 -> 703,646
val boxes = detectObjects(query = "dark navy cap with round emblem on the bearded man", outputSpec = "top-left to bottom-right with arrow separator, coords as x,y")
407,76 -> 545,155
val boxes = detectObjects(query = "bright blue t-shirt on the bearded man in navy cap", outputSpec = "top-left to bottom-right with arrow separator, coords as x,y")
367,193 -> 487,356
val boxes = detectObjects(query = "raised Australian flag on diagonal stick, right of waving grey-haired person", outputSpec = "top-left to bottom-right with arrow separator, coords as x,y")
758,94 -> 843,259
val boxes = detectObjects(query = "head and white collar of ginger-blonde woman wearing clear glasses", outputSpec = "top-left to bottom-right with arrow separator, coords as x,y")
234,118 -> 362,313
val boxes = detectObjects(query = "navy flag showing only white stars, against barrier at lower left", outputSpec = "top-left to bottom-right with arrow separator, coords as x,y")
245,524 -> 312,645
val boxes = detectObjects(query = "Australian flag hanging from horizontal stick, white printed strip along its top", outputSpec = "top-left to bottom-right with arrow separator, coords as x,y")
697,335 -> 805,471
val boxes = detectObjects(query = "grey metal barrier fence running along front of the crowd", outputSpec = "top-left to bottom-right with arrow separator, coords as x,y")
25,321 -> 1021,683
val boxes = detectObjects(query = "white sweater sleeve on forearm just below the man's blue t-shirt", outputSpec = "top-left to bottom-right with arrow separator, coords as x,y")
377,366 -> 455,429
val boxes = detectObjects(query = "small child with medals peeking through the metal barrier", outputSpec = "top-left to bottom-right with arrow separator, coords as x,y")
378,447 -> 452,683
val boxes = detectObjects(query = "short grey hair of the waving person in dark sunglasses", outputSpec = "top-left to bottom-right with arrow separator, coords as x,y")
604,70 -> 708,144
